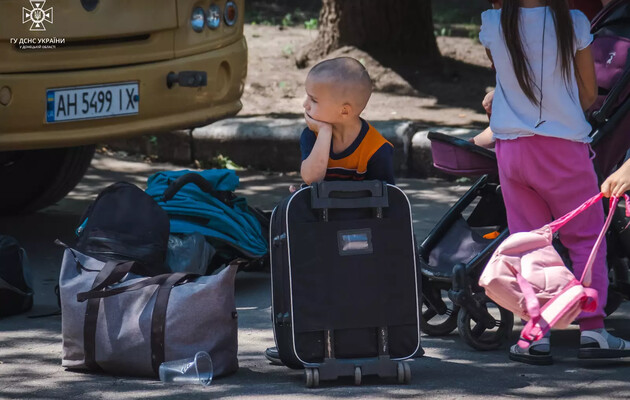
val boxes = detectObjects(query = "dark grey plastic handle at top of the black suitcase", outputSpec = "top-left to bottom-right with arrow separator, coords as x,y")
311,181 -> 389,209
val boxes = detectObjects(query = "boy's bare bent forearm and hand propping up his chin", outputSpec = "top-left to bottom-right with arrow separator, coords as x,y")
300,114 -> 332,185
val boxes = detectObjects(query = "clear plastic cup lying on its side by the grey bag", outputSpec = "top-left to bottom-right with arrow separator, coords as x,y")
159,351 -> 213,386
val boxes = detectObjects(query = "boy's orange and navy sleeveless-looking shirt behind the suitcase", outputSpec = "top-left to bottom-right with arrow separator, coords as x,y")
300,119 -> 394,185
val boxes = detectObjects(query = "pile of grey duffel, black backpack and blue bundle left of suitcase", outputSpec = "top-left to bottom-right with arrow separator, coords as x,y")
59,170 -> 267,377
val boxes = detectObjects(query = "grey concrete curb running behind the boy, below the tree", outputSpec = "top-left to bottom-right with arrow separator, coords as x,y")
107,117 -> 479,178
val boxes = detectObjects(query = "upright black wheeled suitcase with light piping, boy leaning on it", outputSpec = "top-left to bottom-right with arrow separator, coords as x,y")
270,181 -> 423,387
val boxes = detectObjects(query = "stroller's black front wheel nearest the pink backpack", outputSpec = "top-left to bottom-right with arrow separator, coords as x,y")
457,298 -> 514,351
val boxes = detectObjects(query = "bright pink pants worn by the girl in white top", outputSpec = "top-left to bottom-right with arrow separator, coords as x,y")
496,135 -> 608,330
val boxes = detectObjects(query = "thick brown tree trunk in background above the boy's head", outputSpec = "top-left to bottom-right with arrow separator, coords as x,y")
297,0 -> 440,66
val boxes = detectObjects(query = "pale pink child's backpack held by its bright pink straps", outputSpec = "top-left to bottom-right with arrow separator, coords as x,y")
479,193 -> 630,348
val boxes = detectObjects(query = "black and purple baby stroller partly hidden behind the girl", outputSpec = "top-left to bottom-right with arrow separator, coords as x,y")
419,0 -> 630,350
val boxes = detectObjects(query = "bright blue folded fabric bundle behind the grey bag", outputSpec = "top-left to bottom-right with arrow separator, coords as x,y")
146,169 -> 267,258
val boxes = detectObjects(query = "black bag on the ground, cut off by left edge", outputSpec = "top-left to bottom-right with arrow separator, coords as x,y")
0,235 -> 33,317
